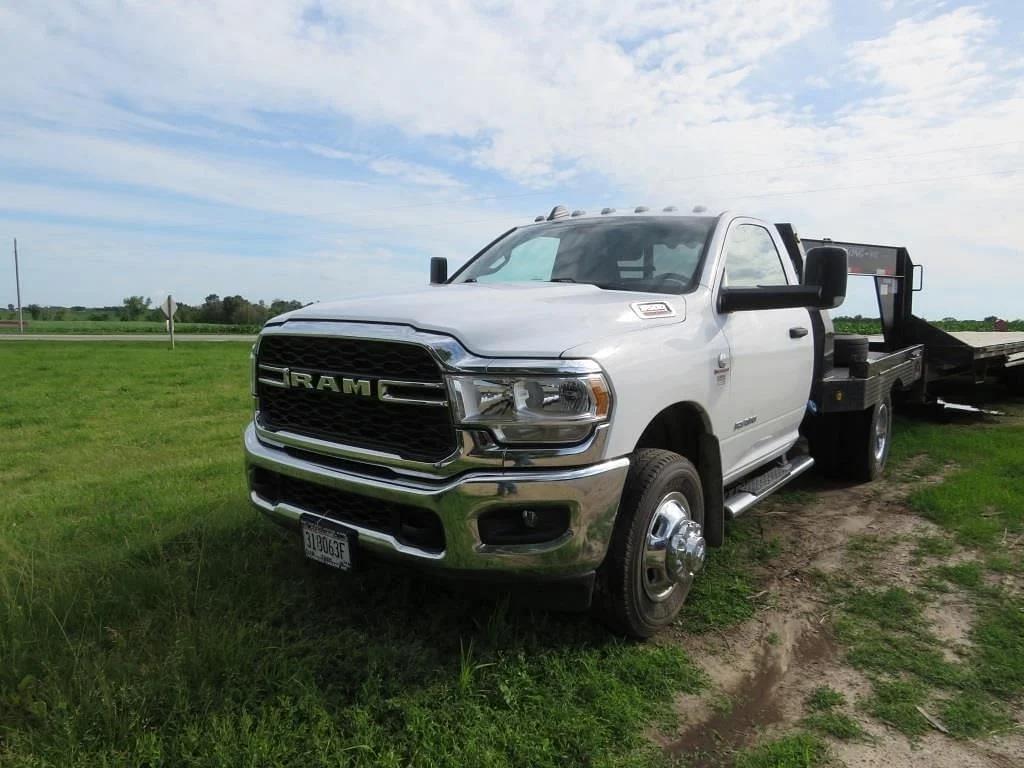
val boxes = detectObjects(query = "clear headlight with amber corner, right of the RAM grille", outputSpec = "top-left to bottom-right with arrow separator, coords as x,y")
449,374 -> 611,442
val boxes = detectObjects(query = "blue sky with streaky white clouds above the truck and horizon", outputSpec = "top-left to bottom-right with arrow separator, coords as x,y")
0,0 -> 1024,317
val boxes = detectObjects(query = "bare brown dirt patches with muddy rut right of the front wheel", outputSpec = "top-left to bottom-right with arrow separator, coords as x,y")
657,467 -> 1024,768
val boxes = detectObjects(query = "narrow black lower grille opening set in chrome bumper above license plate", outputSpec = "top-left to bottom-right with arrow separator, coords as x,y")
252,467 -> 444,552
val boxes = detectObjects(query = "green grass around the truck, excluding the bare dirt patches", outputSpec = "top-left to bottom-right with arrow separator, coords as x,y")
0,342 -> 1024,768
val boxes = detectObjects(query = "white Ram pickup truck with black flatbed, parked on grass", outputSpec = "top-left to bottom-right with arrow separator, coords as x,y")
245,206 -> 922,637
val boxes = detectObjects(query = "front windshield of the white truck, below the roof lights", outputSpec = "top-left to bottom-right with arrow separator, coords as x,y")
453,216 -> 715,293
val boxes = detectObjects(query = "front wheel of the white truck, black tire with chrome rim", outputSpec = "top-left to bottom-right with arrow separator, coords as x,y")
597,450 -> 706,638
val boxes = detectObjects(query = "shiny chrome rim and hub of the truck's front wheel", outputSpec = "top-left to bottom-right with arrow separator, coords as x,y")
640,492 -> 707,602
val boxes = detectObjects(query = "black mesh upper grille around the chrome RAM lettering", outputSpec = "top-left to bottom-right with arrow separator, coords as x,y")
257,336 -> 456,462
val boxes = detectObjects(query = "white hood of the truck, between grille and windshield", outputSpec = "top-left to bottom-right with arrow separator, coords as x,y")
270,283 -> 686,357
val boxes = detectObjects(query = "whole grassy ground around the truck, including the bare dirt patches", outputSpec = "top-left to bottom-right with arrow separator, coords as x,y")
0,344 -> 1024,768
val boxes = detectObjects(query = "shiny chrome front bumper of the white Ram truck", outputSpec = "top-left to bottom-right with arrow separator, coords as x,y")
245,424 -> 629,578
